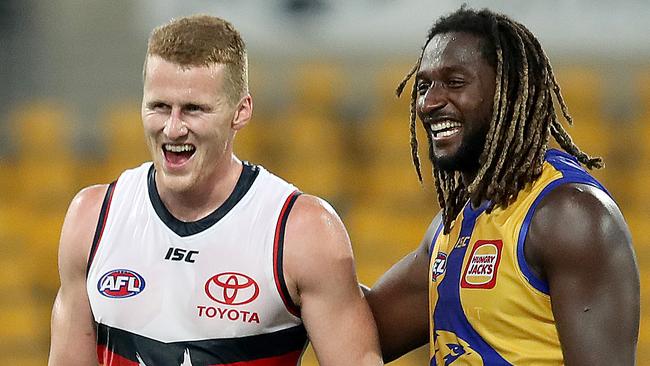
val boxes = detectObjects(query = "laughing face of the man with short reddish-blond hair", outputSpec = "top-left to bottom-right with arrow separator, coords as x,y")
142,56 -> 252,192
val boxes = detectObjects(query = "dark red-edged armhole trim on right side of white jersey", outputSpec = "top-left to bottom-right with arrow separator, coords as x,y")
273,191 -> 302,317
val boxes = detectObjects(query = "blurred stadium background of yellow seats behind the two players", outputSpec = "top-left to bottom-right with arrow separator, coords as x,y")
0,0 -> 650,365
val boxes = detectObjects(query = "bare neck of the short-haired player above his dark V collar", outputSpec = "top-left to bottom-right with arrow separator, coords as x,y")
156,155 -> 243,222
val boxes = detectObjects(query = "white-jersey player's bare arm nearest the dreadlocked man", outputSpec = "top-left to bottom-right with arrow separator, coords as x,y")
284,195 -> 382,366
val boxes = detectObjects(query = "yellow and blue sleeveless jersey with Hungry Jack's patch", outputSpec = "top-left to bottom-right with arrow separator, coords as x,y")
429,150 -> 606,366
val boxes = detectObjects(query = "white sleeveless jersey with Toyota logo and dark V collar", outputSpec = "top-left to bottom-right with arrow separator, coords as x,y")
87,163 -> 307,366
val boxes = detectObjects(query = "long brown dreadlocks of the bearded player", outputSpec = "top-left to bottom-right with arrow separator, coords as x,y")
396,5 -> 604,234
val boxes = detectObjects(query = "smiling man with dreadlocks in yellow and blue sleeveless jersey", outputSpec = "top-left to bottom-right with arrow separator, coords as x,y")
367,7 -> 640,365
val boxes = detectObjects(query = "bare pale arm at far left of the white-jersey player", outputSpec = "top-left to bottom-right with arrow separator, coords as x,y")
48,186 -> 107,366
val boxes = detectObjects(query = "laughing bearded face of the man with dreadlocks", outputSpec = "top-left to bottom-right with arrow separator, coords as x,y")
415,32 -> 496,174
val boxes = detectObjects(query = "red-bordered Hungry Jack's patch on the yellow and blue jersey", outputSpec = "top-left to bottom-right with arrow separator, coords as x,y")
460,240 -> 503,289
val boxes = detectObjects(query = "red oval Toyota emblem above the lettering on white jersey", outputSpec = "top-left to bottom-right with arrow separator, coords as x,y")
205,272 -> 260,305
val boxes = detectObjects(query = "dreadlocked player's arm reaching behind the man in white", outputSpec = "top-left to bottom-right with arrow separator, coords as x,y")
366,213 -> 442,362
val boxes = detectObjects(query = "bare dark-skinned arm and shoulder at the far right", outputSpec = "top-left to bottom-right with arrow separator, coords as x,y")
525,184 -> 640,365
